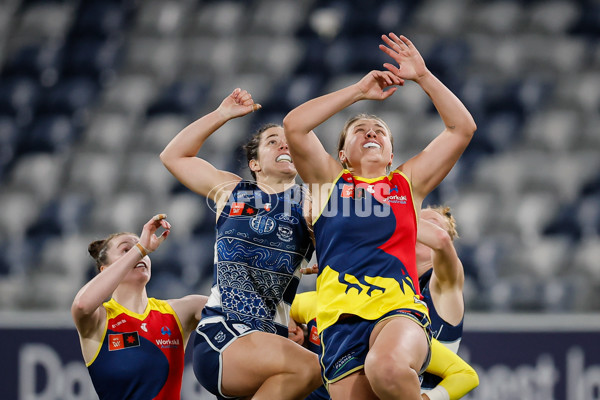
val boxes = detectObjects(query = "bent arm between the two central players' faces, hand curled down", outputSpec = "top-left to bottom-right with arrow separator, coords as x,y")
283,71 -> 404,183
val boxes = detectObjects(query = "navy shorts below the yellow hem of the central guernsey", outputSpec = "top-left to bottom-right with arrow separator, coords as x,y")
319,309 -> 431,385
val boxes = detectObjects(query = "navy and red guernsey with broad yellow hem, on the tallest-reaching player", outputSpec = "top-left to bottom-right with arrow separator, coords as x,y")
313,170 -> 427,332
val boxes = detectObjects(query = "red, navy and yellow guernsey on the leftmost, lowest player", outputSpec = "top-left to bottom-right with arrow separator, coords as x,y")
87,298 -> 185,400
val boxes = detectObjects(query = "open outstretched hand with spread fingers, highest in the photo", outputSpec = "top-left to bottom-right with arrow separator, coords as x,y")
379,33 -> 429,81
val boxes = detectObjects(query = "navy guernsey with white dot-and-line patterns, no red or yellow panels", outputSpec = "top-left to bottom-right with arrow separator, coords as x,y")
200,181 -> 314,337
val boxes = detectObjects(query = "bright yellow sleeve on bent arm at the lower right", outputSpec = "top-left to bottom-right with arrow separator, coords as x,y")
425,339 -> 479,400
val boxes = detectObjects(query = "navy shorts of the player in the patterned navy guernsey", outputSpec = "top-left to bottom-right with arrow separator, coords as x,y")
193,320 -> 257,400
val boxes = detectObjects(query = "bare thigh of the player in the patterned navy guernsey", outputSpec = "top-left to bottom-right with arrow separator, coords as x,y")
222,332 -> 319,395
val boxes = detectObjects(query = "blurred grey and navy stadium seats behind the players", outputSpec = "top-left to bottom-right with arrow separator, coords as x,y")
0,0 -> 600,398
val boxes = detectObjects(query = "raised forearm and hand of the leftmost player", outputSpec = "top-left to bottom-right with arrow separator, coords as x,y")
71,214 -> 171,337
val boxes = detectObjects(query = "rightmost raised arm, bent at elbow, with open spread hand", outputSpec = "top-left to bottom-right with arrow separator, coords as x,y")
379,33 -> 477,203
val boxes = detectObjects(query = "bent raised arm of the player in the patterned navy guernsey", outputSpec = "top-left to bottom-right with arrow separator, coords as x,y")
160,88 -> 261,201
